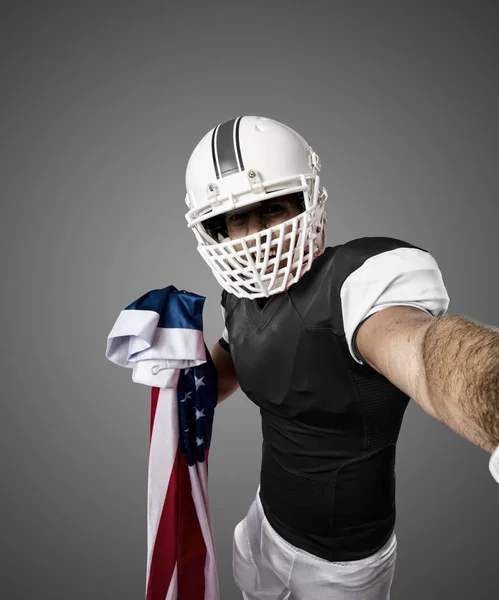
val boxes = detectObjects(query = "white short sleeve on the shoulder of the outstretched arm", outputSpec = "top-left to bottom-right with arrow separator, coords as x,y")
340,247 -> 449,365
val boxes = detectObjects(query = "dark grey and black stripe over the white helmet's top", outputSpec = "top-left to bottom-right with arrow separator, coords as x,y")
211,117 -> 244,179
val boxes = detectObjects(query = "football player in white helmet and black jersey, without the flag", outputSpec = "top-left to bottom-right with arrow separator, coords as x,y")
186,116 -> 499,600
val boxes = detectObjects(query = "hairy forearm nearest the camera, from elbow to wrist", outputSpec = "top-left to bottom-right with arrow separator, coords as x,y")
422,315 -> 499,452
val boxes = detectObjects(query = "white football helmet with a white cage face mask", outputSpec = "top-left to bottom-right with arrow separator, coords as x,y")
185,117 -> 327,298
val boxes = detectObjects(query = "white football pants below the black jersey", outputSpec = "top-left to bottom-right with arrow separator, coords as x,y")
232,488 -> 397,600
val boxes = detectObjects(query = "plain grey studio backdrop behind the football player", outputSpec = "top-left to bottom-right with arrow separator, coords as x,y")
0,0 -> 499,600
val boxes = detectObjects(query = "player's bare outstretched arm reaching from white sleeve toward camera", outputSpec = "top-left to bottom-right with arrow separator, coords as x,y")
356,306 -> 499,453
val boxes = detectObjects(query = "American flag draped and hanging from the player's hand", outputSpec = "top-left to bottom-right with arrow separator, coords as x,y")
106,286 -> 219,600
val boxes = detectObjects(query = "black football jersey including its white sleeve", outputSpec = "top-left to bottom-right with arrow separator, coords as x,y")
221,238 -> 449,561
